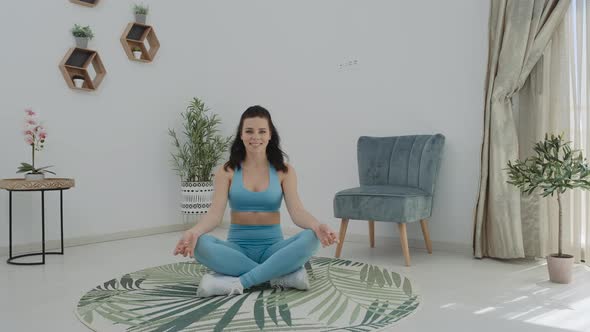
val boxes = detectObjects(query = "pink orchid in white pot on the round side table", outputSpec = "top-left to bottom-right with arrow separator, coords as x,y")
16,108 -> 55,180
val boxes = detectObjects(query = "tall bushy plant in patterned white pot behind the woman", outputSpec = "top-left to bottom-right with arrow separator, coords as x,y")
168,98 -> 231,214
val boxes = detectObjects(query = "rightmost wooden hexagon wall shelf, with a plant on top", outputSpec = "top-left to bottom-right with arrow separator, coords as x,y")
121,22 -> 160,62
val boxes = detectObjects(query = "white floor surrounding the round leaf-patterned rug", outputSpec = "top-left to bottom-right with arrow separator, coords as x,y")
0,229 -> 590,332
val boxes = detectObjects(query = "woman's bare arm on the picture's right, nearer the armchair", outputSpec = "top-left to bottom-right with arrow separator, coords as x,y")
282,165 -> 338,246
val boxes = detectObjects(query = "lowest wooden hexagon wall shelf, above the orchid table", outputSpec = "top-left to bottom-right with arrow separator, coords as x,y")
59,47 -> 107,91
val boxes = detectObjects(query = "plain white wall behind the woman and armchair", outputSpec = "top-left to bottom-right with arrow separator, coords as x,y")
0,0 -> 489,246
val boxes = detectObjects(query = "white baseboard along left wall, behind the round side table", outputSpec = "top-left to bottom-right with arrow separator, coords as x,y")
0,223 -> 191,256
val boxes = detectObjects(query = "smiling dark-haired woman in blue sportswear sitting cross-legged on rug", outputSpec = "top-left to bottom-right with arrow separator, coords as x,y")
174,106 -> 337,297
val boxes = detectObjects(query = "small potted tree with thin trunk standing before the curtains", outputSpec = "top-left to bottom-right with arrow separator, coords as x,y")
508,134 -> 590,283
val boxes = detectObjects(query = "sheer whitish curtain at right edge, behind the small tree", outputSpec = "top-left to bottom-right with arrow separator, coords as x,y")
518,0 -> 590,264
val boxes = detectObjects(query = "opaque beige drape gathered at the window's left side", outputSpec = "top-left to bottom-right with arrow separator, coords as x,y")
473,0 -> 569,258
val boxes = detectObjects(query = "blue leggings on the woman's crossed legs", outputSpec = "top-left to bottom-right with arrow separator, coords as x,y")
194,224 -> 320,288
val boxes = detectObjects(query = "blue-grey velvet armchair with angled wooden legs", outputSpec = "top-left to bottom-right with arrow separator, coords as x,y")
334,134 -> 445,266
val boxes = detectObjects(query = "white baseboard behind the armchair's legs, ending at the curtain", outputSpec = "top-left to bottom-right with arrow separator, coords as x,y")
283,226 -> 472,254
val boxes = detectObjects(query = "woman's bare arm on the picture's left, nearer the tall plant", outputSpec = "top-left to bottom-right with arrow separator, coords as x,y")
174,166 -> 232,257
